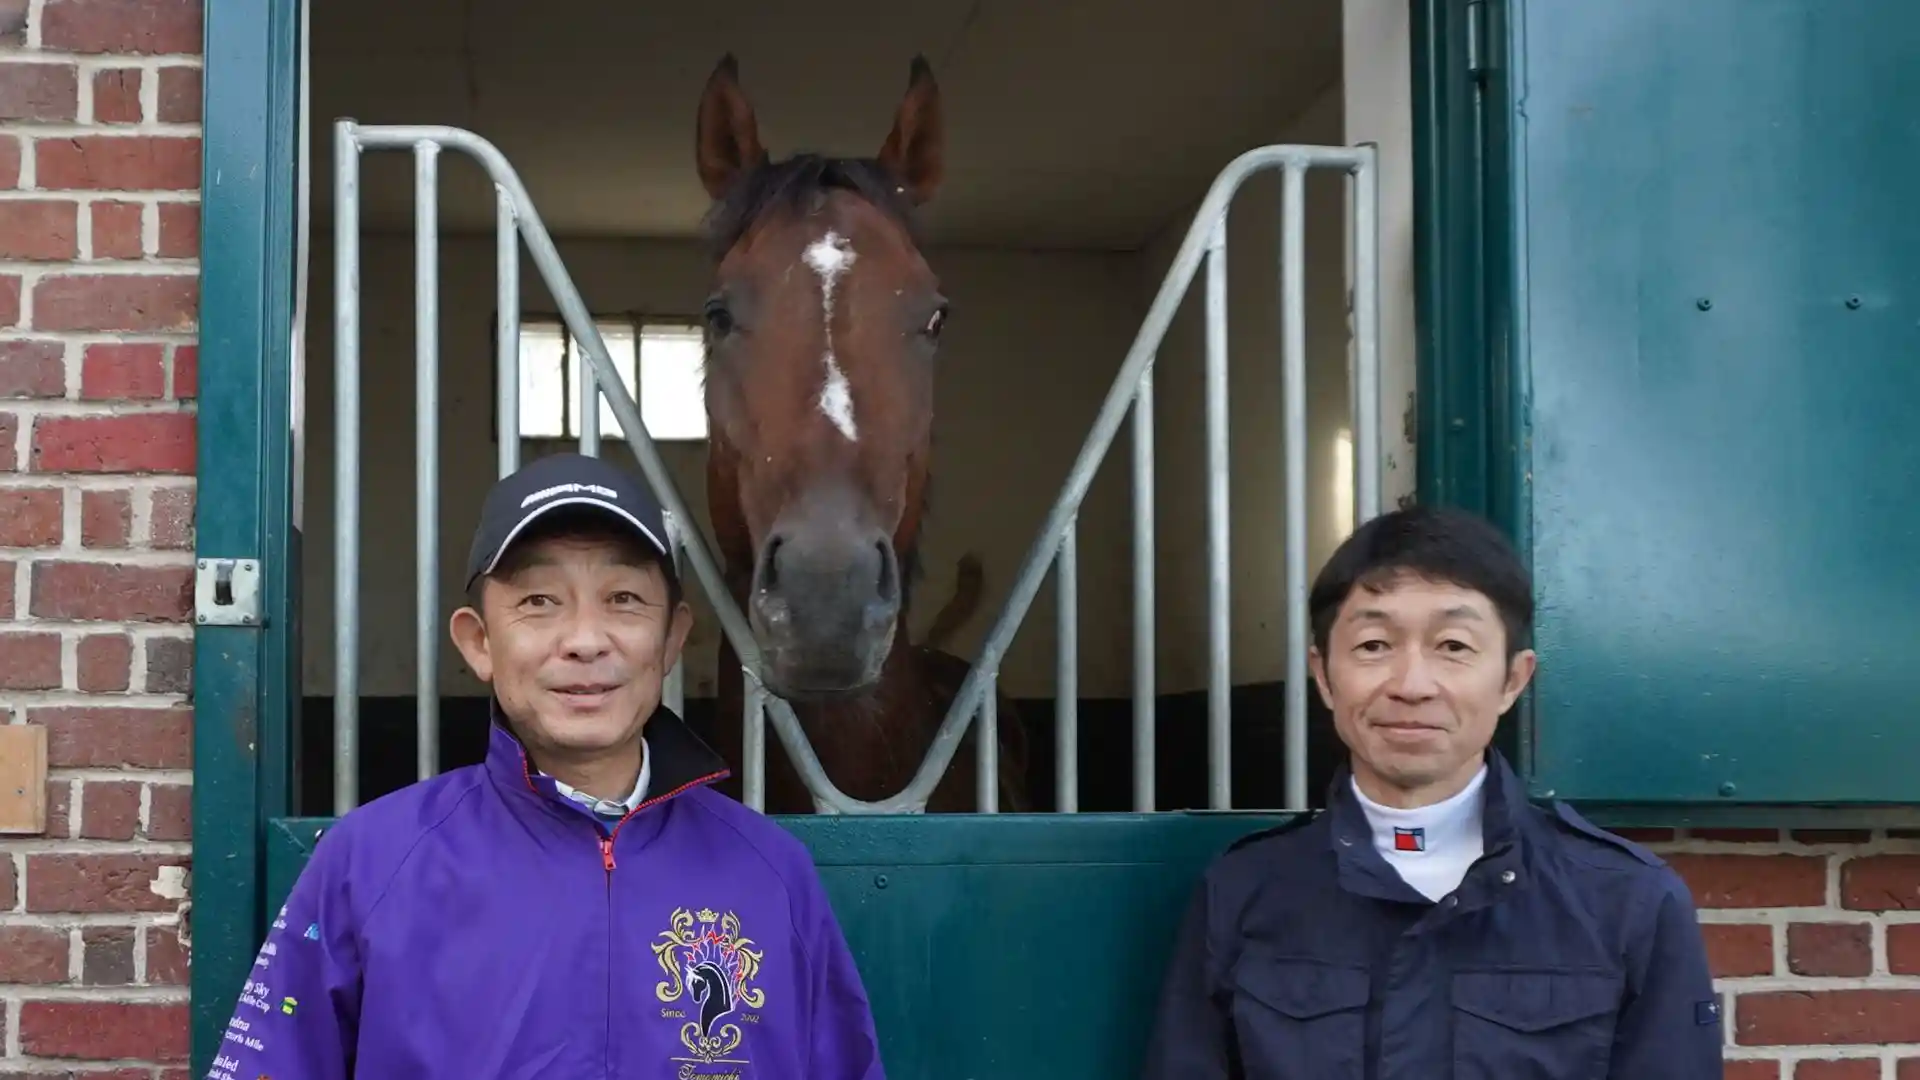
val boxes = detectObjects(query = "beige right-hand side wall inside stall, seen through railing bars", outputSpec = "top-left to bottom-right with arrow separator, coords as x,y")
1140,86 -> 1350,692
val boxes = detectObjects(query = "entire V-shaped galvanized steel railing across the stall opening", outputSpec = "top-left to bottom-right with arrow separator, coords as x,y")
334,119 -> 1380,813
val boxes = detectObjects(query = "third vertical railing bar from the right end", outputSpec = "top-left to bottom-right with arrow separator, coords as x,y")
1206,216 -> 1233,809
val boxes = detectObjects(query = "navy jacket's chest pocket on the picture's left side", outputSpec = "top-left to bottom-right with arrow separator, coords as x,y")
1233,955 -> 1369,1080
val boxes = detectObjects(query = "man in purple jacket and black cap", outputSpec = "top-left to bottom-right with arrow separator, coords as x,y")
207,454 -> 885,1080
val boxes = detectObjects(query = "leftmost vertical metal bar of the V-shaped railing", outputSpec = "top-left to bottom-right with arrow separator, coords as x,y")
334,119 -> 361,817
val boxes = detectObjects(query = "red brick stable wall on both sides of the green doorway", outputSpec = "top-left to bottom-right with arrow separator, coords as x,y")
0,0 -> 1920,1080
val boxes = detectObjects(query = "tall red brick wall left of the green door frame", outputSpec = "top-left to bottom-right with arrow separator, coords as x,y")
0,0 -> 202,1080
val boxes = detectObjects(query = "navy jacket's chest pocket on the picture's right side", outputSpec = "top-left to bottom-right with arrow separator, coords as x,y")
1453,970 -> 1622,1080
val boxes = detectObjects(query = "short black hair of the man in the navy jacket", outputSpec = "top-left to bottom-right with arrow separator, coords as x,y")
1308,505 -> 1534,657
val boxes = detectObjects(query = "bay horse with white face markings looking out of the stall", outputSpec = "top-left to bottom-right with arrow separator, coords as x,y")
695,54 -> 1027,813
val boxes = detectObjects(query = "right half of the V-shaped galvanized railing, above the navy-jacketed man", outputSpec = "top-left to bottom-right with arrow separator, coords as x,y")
908,144 -> 1380,811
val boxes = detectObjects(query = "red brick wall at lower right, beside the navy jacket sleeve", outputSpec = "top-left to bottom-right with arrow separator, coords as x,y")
1630,830 -> 1920,1080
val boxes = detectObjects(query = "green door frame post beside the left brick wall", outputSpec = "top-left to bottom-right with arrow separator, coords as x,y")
190,0 -> 300,1074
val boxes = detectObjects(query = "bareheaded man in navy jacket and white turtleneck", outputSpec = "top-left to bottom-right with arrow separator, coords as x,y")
1144,507 -> 1724,1080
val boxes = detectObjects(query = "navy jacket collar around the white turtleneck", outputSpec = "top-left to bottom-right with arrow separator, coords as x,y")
1327,748 -> 1530,911
